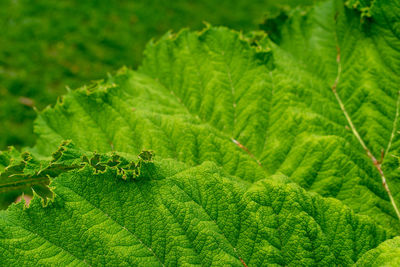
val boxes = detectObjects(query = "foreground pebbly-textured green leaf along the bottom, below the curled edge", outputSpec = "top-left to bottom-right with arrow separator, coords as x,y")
0,144 -> 389,266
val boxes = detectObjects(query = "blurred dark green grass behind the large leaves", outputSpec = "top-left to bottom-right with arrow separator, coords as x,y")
0,0 -> 314,149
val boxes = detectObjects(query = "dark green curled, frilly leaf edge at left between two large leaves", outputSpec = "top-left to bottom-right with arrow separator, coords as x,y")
0,141 -> 153,208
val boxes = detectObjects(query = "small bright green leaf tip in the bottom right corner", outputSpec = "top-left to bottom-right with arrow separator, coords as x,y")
356,237 -> 400,266
